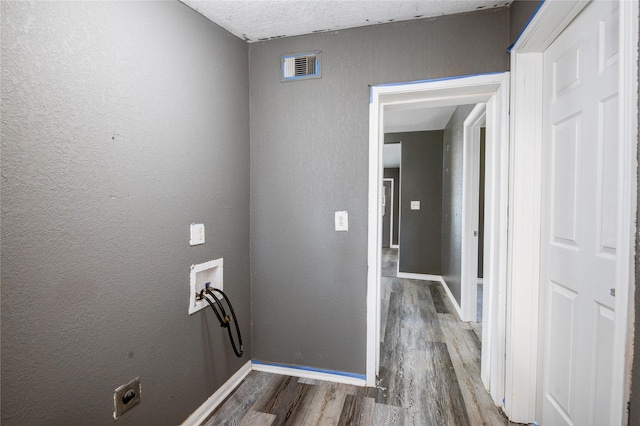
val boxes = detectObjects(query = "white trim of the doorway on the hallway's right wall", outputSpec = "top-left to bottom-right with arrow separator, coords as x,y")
460,104 -> 486,321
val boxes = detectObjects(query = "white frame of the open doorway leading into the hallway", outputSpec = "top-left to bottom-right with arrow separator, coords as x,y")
366,72 -> 510,405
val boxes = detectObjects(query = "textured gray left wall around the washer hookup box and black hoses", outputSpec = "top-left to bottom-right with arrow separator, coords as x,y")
1,1 -> 251,426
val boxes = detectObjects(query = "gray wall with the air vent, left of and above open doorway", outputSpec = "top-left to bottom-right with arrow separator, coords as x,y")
249,8 -> 509,374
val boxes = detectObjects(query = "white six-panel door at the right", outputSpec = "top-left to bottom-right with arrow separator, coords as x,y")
541,1 -> 619,425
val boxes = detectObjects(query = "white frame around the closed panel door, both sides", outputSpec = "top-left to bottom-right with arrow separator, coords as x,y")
504,0 -> 639,425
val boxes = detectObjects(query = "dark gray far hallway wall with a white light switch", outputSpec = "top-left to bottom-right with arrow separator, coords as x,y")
384,130 -> 443,275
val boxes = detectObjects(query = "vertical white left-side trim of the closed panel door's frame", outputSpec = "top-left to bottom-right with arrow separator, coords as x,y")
504,45 -> 542,423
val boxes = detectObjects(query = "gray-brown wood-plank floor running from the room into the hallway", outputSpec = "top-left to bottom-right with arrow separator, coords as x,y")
205,249 -> 509,426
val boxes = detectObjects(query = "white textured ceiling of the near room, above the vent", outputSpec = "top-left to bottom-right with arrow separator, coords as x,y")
180,0 -> 513,43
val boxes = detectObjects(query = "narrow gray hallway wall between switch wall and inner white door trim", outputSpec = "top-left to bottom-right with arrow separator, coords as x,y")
442,105 -> 473,304
